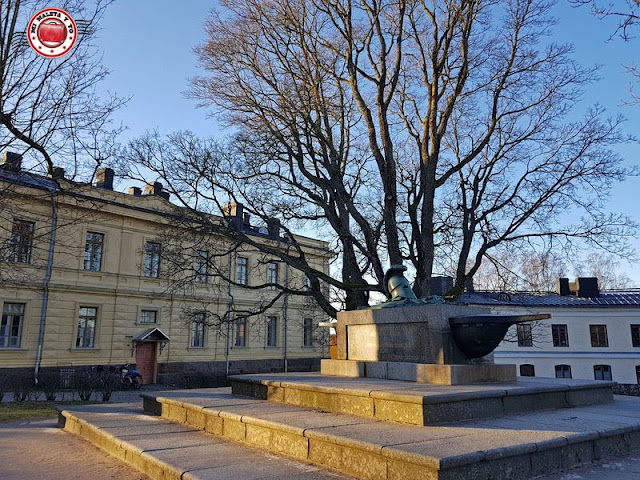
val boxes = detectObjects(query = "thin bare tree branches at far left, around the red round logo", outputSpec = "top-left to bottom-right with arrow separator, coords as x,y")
0,0 -> 125,179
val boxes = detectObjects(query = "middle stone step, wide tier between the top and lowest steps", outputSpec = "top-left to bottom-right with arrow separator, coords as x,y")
142,389 -> 640,480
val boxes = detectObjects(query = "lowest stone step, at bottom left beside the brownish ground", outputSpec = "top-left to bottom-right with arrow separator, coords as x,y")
59,404 -> 349,480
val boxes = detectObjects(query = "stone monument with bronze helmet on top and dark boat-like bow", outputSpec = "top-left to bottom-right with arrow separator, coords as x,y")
321,266 -> 549,385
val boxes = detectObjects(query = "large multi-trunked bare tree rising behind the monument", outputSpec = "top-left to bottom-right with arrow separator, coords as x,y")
122,0 -> 633,312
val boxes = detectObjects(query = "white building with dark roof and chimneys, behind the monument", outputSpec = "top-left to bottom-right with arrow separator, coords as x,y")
459,279 -> 640,384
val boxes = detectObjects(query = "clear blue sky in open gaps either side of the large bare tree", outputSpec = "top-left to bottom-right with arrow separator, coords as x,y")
92,0 -> 640,286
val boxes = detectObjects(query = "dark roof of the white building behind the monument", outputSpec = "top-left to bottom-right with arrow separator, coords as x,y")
456,289 -> 640,308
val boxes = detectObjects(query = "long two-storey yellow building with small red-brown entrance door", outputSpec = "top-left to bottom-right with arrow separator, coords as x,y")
0,153 -> 331,383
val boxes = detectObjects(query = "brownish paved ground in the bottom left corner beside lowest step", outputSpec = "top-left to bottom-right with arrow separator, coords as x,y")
0,417 -> 150,480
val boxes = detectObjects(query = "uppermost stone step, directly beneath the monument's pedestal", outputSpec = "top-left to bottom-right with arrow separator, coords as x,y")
230,373 -> 615,425
